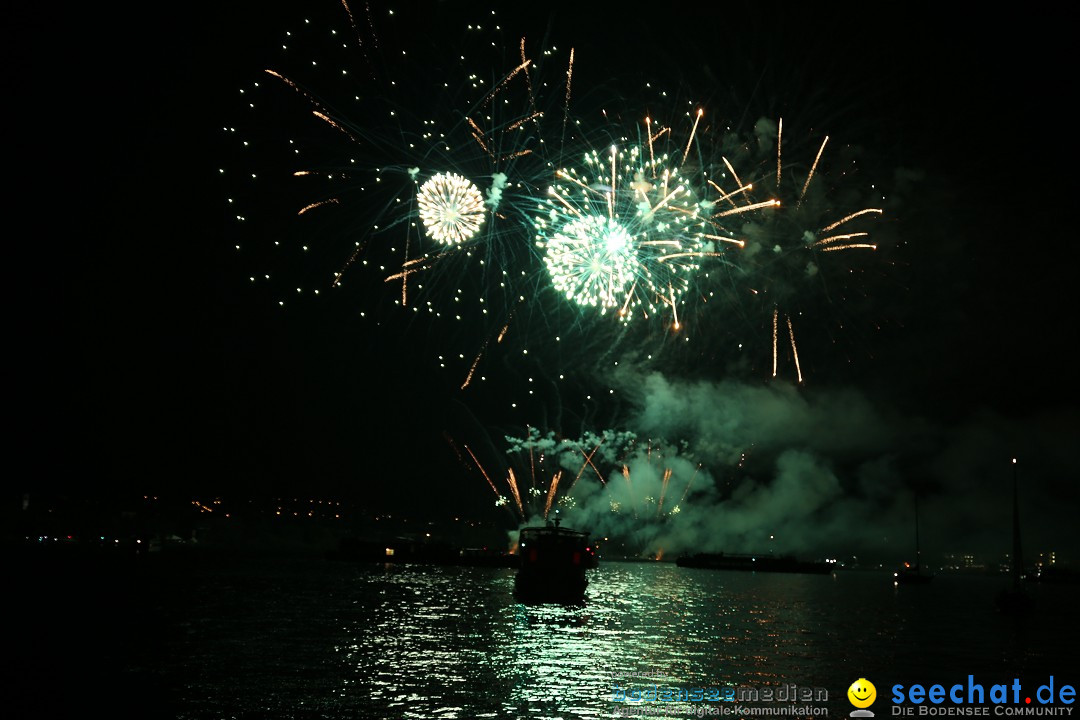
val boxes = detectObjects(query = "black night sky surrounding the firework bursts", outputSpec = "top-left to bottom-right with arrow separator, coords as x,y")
19,0 -> 1080,554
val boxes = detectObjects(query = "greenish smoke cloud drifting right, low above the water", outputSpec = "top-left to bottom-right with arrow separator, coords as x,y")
518,369 -> 1078,565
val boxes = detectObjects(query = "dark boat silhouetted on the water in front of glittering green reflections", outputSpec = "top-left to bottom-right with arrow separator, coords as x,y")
514,519 -> 597,604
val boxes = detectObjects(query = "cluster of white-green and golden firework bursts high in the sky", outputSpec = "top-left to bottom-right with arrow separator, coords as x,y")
227,5 -> 877,416
